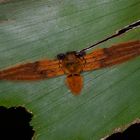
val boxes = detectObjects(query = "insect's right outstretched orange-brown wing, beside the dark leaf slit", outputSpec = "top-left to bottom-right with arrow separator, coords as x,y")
83,40 -> 140,71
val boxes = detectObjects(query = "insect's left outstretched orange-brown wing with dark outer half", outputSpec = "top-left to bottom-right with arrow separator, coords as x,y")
0,60 -> 64,81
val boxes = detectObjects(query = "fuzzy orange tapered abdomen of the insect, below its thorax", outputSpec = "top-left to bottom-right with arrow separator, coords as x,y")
66,74 -> 83,95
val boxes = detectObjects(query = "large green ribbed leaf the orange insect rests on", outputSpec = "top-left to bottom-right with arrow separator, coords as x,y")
0,0 -> 140,140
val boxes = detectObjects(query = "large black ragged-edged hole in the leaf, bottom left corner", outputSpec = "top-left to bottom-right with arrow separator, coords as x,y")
0,106 -> 35,140
